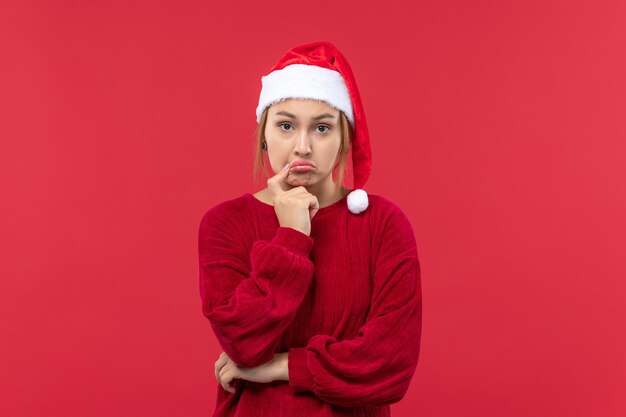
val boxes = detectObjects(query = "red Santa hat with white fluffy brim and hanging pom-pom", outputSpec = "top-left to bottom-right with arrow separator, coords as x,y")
256,41 -> 372,214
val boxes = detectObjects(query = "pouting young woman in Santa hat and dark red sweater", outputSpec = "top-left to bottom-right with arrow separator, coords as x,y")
198,42 -> 422,417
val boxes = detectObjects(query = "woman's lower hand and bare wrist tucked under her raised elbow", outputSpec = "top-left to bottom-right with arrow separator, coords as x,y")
215,352 -> 289,394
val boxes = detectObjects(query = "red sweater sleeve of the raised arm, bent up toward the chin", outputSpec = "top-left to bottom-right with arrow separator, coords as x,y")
198,210 -> 314,368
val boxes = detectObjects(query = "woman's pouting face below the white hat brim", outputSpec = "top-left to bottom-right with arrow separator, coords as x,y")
265,99 -> 341,187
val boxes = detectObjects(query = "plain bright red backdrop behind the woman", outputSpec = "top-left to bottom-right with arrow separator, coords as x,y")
0,0 -> 626,417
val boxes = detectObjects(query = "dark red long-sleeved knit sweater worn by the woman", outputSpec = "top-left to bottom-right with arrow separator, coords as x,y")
198,193 -> 422,417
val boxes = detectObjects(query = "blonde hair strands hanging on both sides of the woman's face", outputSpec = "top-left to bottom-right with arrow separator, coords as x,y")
253,106 -> 354,187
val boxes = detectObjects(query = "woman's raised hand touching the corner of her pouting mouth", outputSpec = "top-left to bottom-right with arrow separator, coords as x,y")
267,164 -> 320,235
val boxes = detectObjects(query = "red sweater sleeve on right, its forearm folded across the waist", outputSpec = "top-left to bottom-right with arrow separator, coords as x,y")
287,208 -> 422,407
